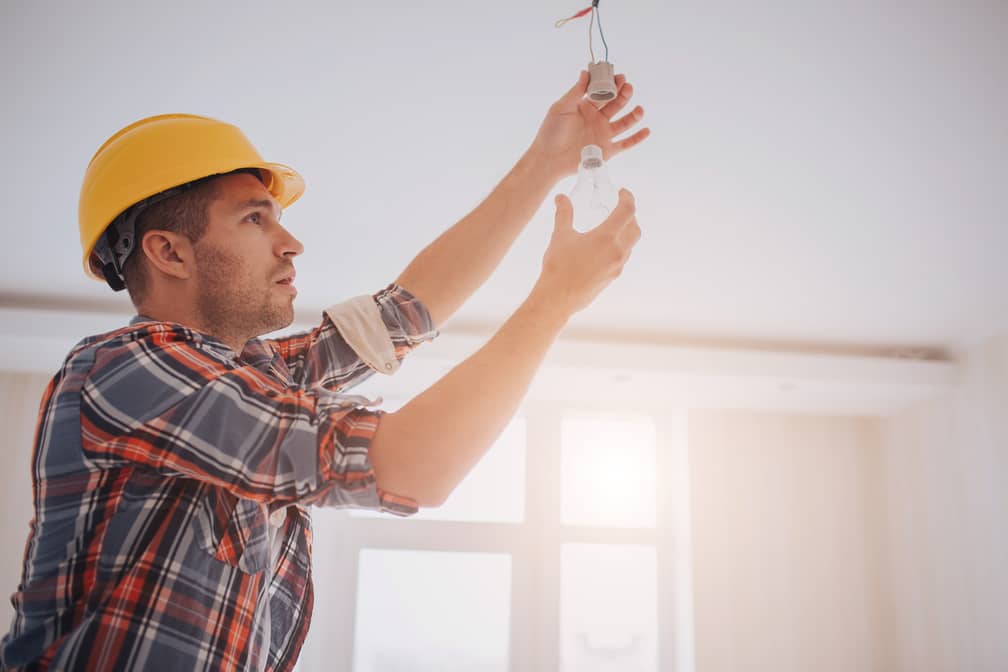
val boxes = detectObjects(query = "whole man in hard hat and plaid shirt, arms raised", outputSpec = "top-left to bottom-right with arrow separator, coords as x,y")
0,73 -> 648,671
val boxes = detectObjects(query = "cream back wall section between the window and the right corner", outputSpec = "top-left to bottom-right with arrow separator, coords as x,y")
689,412 -> 884,672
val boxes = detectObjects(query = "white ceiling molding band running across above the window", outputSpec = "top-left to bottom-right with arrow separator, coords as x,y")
0,302 -> 960,416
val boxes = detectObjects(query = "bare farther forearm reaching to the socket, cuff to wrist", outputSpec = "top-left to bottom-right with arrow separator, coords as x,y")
396,150 -> 556,326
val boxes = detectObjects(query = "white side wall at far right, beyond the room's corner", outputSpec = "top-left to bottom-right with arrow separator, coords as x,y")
882,337 -> 1008,672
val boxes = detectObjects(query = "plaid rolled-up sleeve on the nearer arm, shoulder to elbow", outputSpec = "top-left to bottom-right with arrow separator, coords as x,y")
81,332 -> 416,514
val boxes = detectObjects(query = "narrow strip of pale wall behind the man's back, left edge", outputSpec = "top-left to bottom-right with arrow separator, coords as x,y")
0,373 -> 50,637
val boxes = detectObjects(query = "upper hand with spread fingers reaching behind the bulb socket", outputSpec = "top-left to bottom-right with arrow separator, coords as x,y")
532,71 -> 651,180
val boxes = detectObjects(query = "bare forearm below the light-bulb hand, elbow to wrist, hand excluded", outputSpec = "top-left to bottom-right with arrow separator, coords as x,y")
370,292 -> 566,506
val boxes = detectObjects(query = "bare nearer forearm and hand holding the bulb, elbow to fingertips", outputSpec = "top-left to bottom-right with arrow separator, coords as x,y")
368,189 -> 640,507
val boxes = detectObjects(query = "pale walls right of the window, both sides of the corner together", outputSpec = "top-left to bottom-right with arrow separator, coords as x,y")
689,335 -> 1008,672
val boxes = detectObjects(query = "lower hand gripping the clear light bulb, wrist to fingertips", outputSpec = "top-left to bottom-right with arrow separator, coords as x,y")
532,189 -> 640,317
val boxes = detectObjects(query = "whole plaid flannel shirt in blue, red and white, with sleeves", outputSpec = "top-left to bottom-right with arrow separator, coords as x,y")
0,285 -> 437,672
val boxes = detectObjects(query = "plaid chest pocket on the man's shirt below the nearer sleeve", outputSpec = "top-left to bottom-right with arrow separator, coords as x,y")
195,489 -> 270,574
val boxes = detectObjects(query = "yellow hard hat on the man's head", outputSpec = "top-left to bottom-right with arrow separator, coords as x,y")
78,114 -> 304,280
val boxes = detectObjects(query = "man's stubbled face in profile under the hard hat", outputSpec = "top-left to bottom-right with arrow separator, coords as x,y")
195,173 -> 304,344
